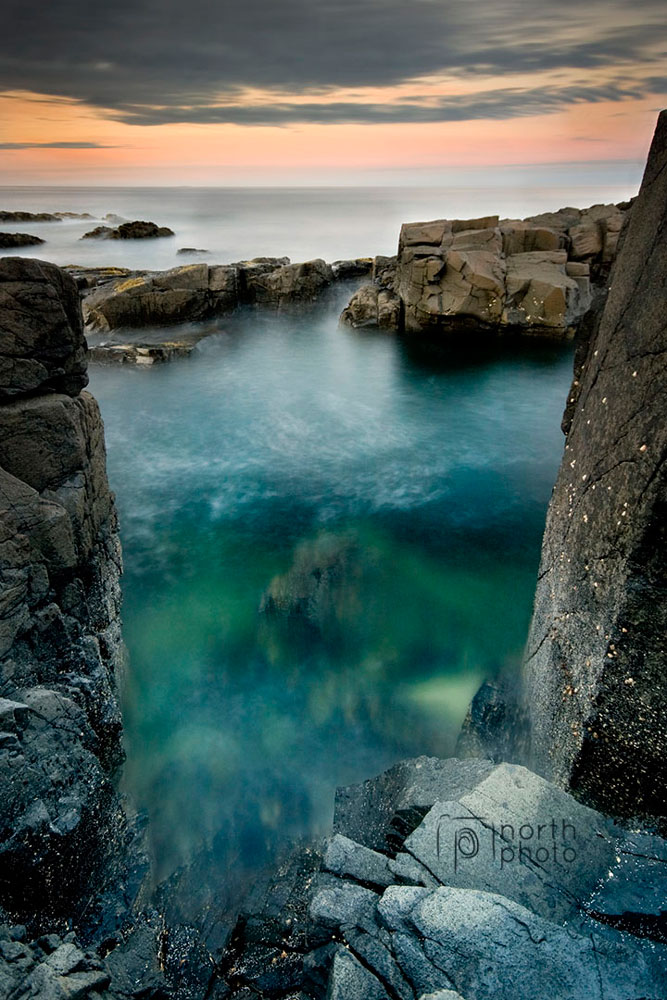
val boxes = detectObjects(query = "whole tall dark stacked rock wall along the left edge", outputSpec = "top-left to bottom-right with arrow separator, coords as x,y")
0,259 -> 124,926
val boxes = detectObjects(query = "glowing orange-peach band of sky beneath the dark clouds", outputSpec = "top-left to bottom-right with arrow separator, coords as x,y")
0,85 -> 660,185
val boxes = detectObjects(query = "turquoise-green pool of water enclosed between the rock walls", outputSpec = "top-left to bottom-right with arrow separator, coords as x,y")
86,290 -> 571,877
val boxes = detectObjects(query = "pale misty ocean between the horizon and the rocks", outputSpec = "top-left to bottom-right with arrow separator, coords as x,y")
0,183 -> 636,268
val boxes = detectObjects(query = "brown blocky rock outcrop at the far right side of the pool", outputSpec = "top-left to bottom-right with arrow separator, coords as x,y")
341,205 -> 623,337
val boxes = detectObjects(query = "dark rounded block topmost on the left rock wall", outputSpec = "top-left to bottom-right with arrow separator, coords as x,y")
0,257 -> 88,403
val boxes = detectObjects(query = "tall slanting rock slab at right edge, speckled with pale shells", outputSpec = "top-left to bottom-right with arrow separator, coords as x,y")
524,112 -> 667,816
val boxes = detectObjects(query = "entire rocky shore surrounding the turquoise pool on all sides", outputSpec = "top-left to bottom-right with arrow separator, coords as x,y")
0,113 -> 667,1000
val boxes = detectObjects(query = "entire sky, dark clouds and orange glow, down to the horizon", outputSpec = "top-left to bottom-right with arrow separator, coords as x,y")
0,0 -> 667,185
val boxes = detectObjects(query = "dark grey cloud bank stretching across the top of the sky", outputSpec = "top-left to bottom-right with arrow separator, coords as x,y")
0,0 -> 663,124
